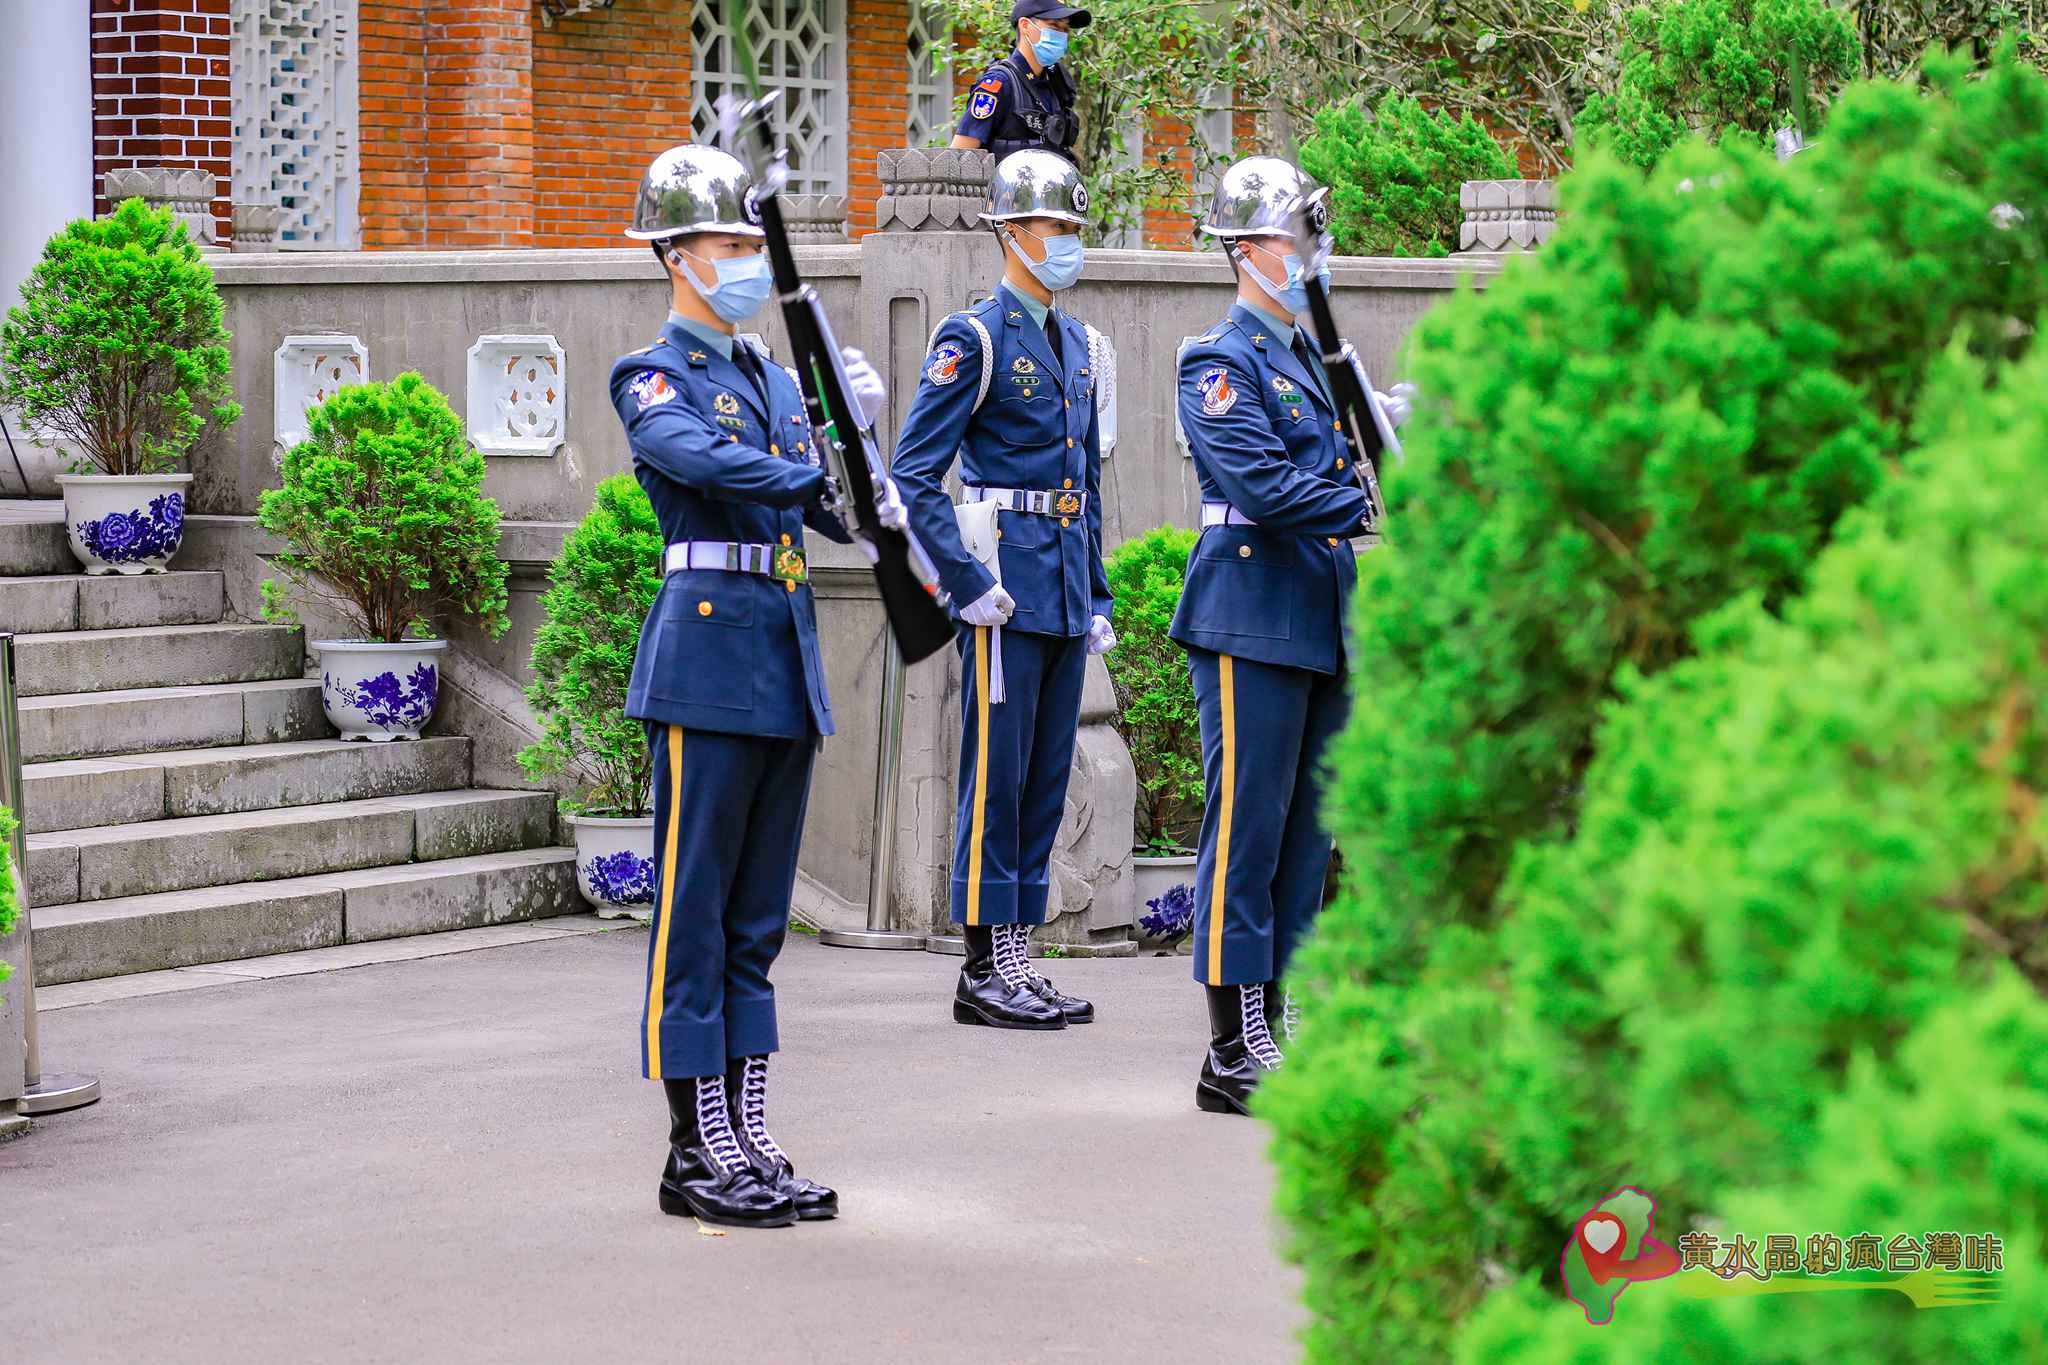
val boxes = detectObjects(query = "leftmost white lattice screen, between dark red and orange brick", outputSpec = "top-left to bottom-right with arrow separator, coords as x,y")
233,0 -> 356,250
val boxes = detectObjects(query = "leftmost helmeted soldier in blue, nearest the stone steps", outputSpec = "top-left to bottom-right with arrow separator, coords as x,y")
612,145 -> 903,1228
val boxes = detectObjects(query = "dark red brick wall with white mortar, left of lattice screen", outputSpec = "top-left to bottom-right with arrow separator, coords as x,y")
91,0 -> 233,244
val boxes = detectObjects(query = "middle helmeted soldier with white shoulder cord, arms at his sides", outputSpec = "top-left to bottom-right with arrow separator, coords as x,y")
891,151 -> 1116,1029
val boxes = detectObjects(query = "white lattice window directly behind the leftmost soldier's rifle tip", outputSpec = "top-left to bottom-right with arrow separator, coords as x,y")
690,0 -> 846,194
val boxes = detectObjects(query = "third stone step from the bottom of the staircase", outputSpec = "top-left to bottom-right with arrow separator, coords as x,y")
23,737 -> 469,835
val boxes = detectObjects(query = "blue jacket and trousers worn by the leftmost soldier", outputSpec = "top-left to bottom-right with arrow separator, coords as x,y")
612,315 -> 846,1078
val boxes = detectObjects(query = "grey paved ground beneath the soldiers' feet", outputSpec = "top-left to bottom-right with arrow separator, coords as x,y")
0,929 -> 1298,1365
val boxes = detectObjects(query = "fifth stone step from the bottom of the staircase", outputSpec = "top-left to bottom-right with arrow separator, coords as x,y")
14,624 -> 305,698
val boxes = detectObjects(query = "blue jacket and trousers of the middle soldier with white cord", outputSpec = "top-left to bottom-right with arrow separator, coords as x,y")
889,284 -> 1110,927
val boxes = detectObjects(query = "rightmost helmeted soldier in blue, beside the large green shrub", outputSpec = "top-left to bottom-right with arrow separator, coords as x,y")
1171,156 -> 1407,1113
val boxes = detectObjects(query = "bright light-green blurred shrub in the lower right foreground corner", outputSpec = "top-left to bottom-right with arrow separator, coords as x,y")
1460,341 -> 2048,1365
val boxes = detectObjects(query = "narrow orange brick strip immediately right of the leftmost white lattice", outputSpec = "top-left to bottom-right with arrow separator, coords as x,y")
356,0 -> 428,250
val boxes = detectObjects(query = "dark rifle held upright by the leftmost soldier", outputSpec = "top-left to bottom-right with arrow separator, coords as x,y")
723,38 -> 954,663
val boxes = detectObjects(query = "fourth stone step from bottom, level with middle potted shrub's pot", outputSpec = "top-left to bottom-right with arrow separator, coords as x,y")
20,677 -> 334,763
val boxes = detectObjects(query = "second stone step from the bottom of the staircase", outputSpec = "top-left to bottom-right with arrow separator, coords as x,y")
29,790 -> 555,907
